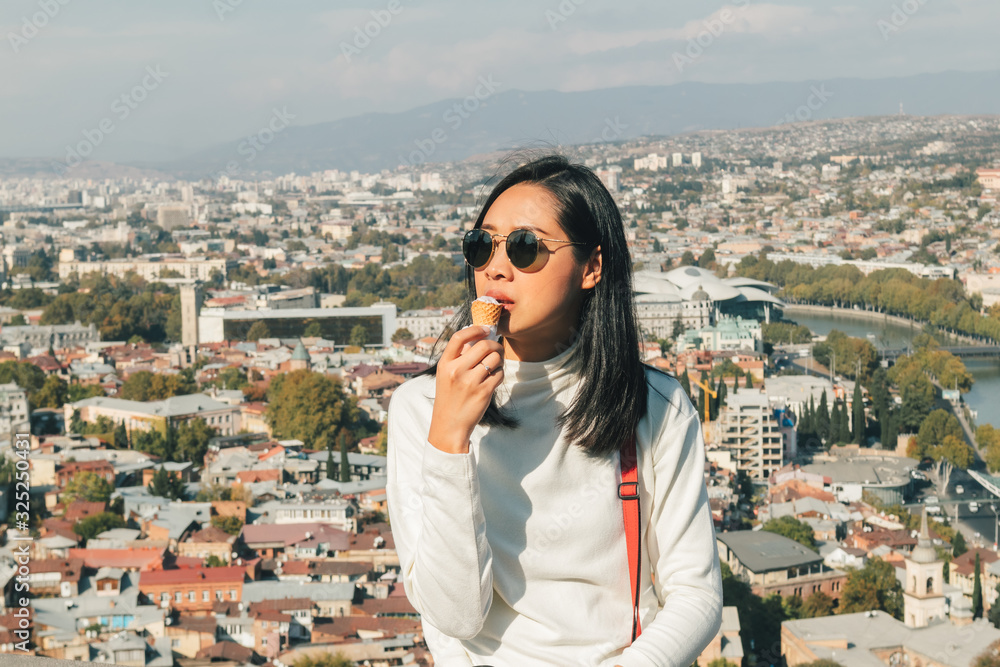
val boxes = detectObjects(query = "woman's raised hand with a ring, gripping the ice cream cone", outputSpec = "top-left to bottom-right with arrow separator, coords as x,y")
427,326 -> 503,454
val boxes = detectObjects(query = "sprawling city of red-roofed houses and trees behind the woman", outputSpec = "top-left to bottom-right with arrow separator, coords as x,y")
0,99 -> 1000,667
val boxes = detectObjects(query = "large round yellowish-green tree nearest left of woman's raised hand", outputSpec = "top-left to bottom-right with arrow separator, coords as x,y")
267,369 -> 359,450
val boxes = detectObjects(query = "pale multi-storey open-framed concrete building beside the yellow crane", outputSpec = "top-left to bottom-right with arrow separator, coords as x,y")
715,389 -> 784,482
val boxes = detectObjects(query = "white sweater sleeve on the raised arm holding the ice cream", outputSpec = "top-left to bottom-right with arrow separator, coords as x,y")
386,387 -> 493,639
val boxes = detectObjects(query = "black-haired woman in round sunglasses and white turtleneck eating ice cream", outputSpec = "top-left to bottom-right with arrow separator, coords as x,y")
387,156 -> 722,667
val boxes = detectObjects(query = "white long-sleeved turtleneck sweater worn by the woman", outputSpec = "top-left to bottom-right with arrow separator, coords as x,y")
386,346 -> 722,667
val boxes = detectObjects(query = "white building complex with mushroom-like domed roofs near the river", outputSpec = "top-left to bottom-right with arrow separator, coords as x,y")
633,266 -> 785,338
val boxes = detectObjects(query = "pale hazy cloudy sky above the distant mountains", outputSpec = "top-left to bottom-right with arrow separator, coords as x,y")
0,0 -> 1000,161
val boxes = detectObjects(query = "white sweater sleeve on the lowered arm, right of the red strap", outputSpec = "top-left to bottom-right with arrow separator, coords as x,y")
609,409 -> 722,667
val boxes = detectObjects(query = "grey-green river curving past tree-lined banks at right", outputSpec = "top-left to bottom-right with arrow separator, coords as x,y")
785,311 -> 1000,428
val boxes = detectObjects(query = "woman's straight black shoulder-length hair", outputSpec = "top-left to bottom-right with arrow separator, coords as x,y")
418,155 -> 646,456
